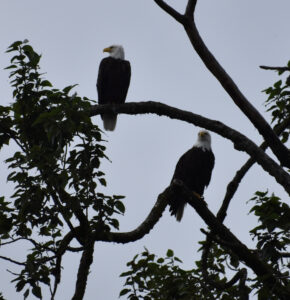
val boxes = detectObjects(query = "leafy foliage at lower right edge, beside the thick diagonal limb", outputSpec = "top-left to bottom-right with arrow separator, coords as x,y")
250,192 -> 290,299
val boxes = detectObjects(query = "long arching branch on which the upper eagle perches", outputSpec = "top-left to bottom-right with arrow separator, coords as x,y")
91,101 -> 290,195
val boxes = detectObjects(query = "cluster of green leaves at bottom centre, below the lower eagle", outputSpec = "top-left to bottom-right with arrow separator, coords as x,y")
120,244 -> 245,300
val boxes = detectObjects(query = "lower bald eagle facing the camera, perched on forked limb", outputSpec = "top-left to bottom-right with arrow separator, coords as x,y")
169,130 -> 215,221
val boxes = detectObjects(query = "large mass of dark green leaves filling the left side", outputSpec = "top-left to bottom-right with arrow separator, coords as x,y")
0,41 -> 125,298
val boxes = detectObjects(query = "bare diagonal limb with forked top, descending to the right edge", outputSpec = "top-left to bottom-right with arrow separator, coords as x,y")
154,0 -> 290,168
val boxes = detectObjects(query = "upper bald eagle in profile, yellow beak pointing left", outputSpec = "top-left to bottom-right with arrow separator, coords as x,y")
97,45 -> 131,131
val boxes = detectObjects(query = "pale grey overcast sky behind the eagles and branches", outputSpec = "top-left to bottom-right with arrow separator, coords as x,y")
0,0 -> 290,300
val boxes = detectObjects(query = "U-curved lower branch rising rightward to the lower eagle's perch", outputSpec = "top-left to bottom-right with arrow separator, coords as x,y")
94,188 -> 169,244
